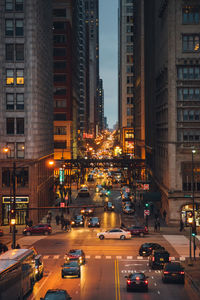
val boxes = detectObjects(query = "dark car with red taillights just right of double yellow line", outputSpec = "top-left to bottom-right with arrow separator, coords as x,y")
125,272 -> 149,292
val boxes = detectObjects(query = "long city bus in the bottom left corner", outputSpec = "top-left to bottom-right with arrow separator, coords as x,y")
0,249 -> 37,300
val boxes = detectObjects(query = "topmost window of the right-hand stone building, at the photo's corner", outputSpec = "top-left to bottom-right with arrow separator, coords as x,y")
182,6 -> 200,24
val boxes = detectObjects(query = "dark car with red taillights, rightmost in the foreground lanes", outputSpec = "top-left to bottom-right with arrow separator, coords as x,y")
162,262 -> 185,284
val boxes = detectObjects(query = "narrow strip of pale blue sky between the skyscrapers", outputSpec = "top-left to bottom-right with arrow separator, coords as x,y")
99,0 -> 118,128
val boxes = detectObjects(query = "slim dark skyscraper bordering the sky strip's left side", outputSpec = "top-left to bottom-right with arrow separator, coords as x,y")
85,0 -> 99,135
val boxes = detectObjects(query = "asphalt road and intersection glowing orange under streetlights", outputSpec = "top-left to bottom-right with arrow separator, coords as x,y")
23,182 -> 191,300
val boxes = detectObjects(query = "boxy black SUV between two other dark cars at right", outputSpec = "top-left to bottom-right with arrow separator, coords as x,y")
149,250 -> 170,269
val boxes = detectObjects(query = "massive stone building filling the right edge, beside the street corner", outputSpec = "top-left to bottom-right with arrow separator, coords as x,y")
136,0 -> 200,225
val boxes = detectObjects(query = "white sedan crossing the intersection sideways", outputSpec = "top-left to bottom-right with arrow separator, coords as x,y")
97,228 -> 131,240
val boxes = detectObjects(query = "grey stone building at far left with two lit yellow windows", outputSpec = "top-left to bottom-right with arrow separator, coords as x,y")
0,0 -> 53,225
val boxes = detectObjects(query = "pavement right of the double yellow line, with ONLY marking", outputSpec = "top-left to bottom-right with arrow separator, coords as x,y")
118,260 -> 191,300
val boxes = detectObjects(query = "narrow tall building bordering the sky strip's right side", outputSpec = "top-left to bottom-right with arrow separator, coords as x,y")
118,0 -> 135,154
